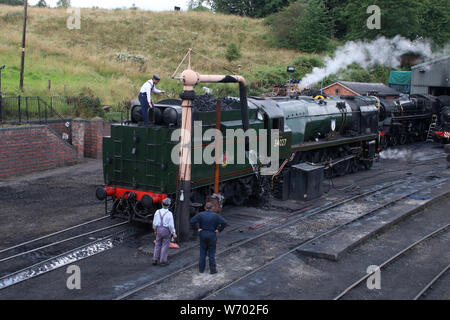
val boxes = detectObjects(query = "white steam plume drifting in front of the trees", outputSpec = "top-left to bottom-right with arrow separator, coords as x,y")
298,35 -> 437,90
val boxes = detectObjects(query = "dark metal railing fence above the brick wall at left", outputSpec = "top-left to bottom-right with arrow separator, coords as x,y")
0,96 -> 75,124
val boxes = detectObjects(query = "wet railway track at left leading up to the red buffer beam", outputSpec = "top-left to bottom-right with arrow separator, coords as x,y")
0,217 -> 129,290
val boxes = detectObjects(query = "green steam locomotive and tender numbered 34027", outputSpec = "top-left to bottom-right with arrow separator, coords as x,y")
96,96 -> 379,222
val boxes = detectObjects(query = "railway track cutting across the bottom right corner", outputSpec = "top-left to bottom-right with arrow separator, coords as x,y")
333,224 -> 450,300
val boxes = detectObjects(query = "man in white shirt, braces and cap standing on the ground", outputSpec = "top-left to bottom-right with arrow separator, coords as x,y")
153,198 -> 177,266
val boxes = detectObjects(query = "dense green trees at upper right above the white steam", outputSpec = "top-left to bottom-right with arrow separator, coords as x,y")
264,0 -> 450,52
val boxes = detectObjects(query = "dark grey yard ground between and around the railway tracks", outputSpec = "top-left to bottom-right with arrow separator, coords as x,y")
0,143 -> 450,299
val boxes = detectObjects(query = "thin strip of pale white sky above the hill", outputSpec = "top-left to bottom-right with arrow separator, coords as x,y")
28,0 -> 188,11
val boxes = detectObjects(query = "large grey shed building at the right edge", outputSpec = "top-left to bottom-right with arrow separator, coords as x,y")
411,56 -> 450,96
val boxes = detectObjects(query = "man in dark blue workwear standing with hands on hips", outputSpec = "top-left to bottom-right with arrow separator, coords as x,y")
190,202 -> 227,274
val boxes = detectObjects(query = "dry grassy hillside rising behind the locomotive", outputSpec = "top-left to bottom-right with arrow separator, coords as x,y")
0,5 -> 301,106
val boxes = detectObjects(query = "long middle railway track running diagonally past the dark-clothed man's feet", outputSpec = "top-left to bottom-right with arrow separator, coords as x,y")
116,172 -> 446,300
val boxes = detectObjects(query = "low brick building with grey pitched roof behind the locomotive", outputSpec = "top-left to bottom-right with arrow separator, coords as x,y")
323,81 -> 400,100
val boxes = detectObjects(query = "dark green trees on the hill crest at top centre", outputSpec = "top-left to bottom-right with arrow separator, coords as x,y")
208,0 -> 295,18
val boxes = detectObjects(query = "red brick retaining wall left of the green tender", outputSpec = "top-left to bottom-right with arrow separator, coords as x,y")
0,118 -> 111,179
